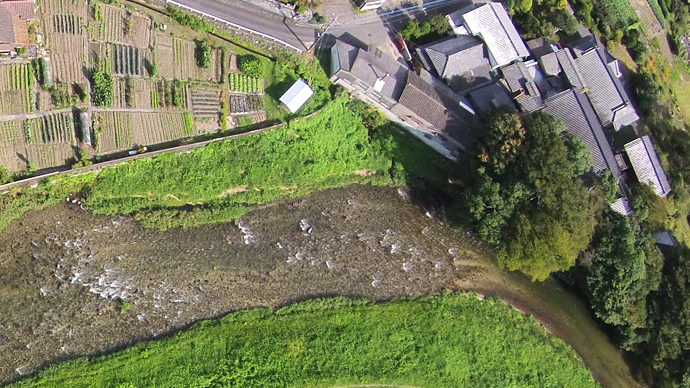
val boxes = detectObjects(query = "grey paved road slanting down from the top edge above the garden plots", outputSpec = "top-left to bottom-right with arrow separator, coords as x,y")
175,0 -> 316,50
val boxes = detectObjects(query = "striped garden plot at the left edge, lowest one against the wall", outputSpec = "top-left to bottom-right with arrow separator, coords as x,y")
0,113 -> 76,171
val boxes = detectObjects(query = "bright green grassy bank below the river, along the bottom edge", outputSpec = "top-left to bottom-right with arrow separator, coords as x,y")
13,294 -> 598,388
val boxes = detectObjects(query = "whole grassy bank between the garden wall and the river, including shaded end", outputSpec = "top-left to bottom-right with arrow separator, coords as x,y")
0,94 -> 452,230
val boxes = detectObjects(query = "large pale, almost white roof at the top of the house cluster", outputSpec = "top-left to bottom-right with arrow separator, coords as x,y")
449,2 -> 529,67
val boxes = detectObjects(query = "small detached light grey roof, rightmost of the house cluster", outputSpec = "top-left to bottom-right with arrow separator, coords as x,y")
624,136 -> 671,197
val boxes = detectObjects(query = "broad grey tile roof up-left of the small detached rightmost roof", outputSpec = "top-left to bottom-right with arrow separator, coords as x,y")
575,48 -> 627,126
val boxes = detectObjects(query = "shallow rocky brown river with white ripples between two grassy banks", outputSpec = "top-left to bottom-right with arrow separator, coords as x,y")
0,186 -> 639,388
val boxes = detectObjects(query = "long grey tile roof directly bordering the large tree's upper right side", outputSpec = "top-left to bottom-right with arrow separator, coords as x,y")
544,89 -> 622,178
